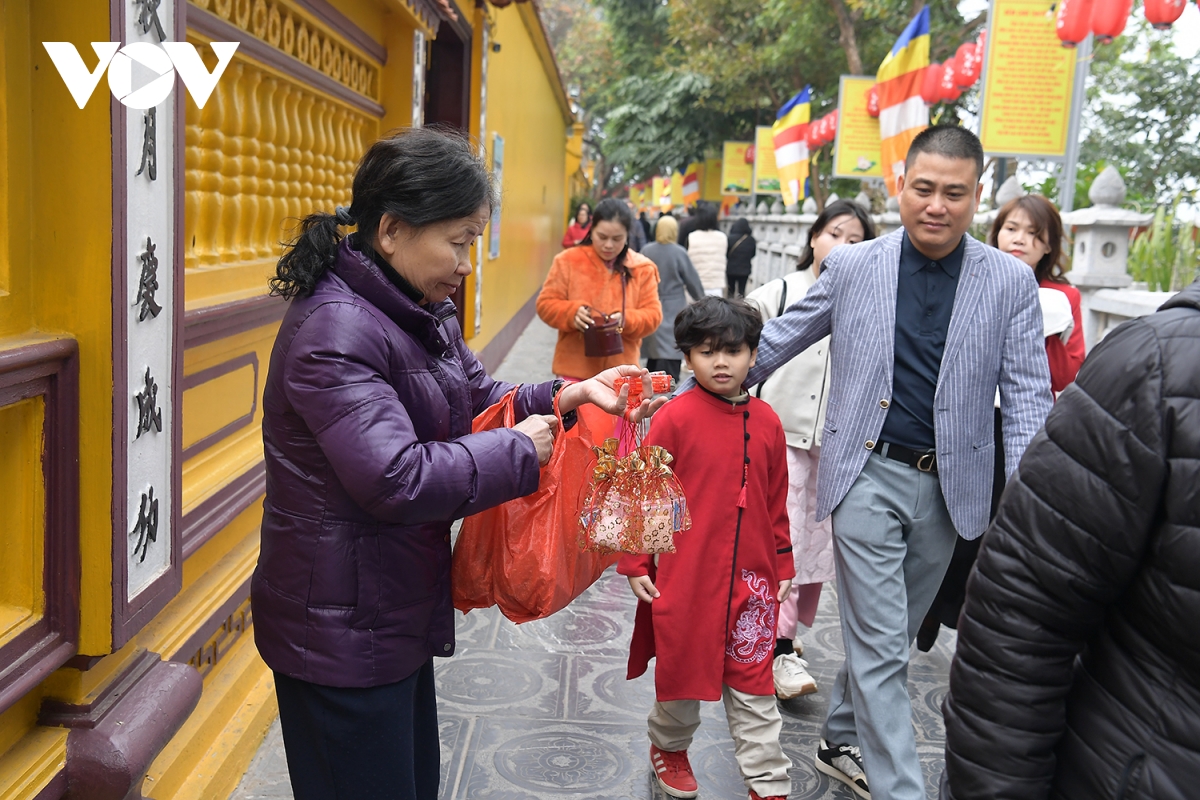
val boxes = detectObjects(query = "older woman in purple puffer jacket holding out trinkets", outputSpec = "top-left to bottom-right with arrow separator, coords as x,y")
251,128 -> 661,800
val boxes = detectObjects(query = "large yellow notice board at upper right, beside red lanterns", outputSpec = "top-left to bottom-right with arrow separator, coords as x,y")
979,0 -> 1075,158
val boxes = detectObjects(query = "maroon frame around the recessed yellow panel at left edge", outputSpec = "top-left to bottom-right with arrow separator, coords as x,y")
0,339 -> 79,712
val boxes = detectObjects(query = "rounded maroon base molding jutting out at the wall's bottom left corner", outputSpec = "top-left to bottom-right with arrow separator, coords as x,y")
38,651 -> 204,800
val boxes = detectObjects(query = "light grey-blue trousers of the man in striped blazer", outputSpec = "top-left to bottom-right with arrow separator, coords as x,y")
824,453 -> 958,800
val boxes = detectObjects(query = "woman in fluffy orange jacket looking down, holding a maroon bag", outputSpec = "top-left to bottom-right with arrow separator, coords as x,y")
538,198 -> 662,380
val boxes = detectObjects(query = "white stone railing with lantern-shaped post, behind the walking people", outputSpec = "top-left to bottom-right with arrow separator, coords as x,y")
721,167 -> 1175,349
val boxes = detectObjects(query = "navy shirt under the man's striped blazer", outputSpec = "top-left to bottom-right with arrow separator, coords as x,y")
880,233 -> 966,450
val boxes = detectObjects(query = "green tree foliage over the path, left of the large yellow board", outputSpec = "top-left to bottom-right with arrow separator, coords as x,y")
544,0 -> 984,190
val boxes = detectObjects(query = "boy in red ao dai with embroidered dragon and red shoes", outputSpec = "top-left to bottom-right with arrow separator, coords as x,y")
617,297 -> 796,800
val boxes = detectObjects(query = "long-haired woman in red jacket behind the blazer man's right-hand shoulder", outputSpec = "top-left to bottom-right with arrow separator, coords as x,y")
988,194 -> 1085,395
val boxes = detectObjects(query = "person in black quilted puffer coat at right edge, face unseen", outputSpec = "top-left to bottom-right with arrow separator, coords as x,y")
942,277 -> 1200,800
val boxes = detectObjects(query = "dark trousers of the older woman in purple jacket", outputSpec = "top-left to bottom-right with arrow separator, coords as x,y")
275,660 -> 442,800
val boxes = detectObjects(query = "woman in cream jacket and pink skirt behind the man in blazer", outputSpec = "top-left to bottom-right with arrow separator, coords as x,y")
744,200 -> 875,699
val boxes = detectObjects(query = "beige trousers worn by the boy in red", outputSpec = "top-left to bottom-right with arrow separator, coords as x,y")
648,686 -> 792,798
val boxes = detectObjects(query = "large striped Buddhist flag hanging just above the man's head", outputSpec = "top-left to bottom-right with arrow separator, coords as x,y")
875,6 -> 929,197
